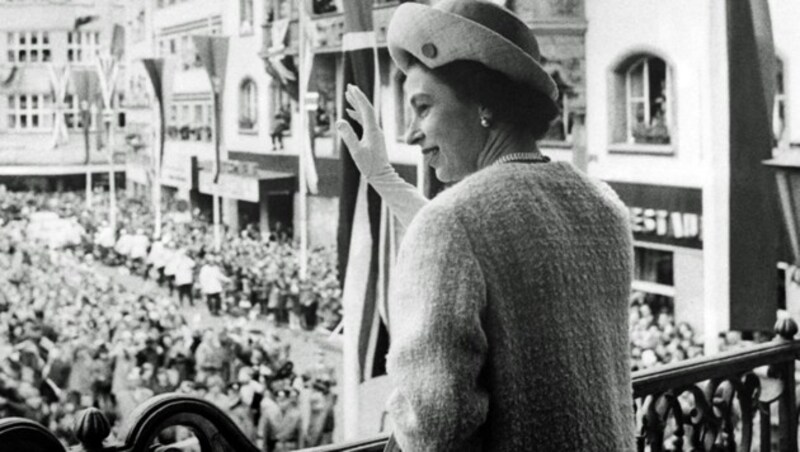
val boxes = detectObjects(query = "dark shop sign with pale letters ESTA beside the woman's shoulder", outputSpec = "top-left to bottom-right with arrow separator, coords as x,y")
609,182 -> 703,249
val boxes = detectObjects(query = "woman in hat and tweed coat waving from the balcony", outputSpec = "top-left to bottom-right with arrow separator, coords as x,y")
337,0 -> 634,451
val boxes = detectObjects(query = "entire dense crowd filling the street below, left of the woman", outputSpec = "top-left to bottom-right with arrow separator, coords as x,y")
0,192 -> 337,450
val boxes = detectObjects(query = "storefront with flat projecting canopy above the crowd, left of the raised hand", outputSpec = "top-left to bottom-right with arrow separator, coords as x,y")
198,161 -> 297,232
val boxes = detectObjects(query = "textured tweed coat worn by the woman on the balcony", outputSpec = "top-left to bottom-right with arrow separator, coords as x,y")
387,162 -> 634,452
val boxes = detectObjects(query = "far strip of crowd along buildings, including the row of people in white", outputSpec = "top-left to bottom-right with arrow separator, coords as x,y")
2,188 -> 342,330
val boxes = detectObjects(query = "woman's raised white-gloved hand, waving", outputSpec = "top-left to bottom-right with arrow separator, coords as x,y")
336,85 -> 391,179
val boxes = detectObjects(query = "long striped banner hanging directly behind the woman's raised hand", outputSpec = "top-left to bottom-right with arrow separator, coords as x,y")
337,0 -> 400,439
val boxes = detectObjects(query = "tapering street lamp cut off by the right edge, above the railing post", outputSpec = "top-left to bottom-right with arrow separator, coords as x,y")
763,153 -> 800,284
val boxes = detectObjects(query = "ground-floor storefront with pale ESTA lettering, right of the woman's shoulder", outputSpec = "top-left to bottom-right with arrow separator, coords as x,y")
610,182 -> 703,330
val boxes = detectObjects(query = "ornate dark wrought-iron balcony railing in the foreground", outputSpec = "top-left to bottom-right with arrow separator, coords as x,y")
0,319 -> 800,452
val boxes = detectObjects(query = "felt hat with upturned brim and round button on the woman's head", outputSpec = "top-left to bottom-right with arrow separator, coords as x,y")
386,0 -> 558,102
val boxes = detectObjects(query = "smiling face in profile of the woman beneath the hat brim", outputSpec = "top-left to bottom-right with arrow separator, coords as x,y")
405,65 -> 488,182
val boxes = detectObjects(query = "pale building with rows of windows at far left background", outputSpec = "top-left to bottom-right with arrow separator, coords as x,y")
0,0 -> 125,190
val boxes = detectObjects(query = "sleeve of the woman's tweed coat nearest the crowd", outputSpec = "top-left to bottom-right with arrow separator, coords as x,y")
387,205 -> 489,452
